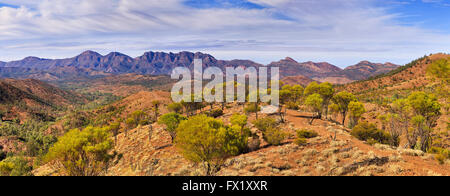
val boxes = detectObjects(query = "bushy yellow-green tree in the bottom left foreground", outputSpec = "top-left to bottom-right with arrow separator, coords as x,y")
45,127 -> 113,176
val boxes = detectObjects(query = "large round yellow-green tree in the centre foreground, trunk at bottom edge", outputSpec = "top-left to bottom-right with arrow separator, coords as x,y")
175,115 -> 247,176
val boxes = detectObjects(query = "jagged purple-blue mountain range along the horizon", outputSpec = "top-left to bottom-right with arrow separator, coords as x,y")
0,51 -> 398,83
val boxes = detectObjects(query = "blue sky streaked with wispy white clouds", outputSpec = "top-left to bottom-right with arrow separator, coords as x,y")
0,0 -> 450,67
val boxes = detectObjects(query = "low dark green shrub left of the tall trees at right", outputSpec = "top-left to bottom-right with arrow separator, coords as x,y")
351,122 -> 391,144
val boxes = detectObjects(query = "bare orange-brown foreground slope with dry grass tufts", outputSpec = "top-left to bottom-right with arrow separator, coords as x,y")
42,107 -> 450,176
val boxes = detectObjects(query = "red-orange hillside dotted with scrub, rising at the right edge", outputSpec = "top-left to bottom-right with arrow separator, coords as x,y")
338,53 -> 450,148
